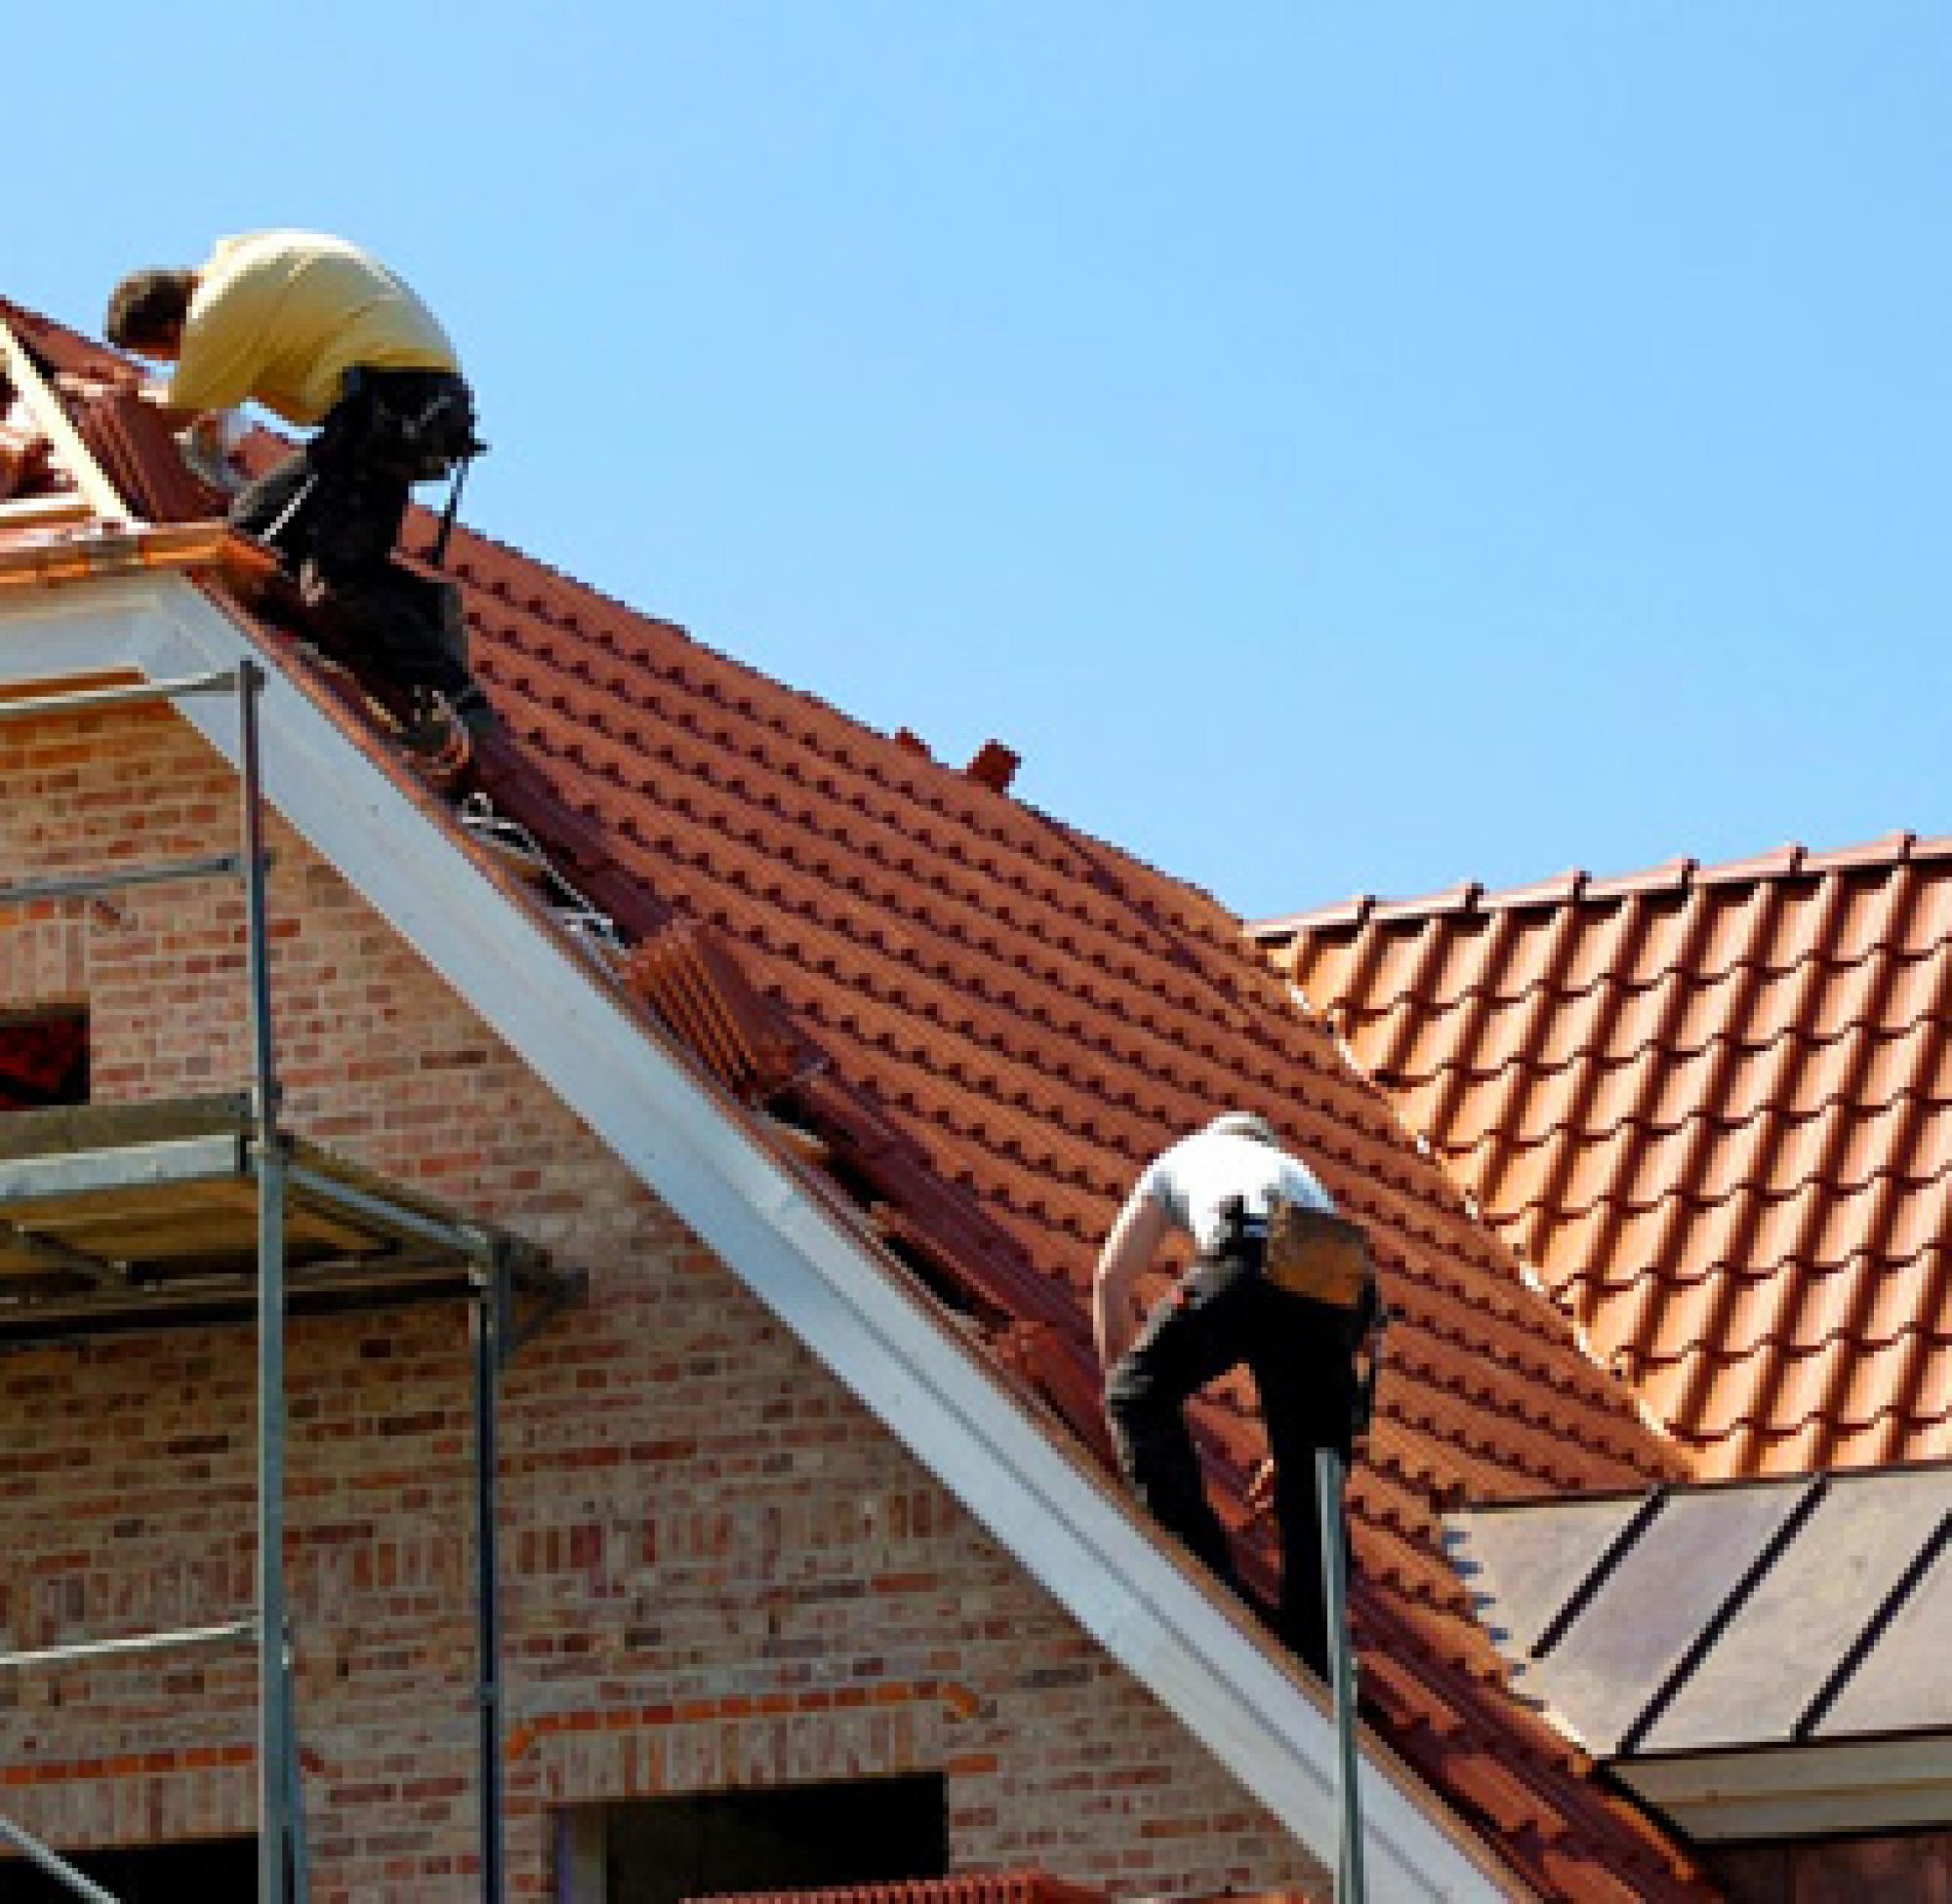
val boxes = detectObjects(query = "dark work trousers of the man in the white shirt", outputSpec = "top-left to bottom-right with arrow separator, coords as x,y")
1105,1238 -> 1355,1678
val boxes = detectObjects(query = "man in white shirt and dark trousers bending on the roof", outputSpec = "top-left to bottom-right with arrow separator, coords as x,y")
1091,1110 -> 1359,1674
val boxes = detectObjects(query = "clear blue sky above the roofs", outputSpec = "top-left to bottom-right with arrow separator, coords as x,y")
4,0 -> 1952,917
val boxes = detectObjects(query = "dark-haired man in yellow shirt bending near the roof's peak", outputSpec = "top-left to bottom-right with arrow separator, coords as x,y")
107,232 -> 496,734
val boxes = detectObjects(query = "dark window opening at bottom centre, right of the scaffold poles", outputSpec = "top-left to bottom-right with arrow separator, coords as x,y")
576,1773 -> 949,1904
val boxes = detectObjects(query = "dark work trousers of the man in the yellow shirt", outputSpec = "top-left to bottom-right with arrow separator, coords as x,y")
230,371 -> 474,701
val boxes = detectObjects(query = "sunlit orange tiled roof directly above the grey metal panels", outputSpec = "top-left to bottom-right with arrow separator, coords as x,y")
1255,850 -> 1952,1477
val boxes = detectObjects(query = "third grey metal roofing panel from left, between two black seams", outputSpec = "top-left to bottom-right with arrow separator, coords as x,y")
1640,1469 -> 1952,1752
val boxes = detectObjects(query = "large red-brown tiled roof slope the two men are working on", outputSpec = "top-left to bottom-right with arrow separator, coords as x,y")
11,304 -> 1708,1898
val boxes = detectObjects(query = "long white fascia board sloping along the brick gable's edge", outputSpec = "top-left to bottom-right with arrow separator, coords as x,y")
0,576 -> 1530,1904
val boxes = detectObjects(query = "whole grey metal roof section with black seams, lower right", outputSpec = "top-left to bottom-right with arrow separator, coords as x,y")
1448,1463 -> 1952,1760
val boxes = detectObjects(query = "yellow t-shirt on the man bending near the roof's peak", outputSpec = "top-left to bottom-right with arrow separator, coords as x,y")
170,232 -> 461,424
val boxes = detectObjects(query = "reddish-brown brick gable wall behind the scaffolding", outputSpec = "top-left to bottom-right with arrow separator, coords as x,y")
0,710 -> 1320,1904
